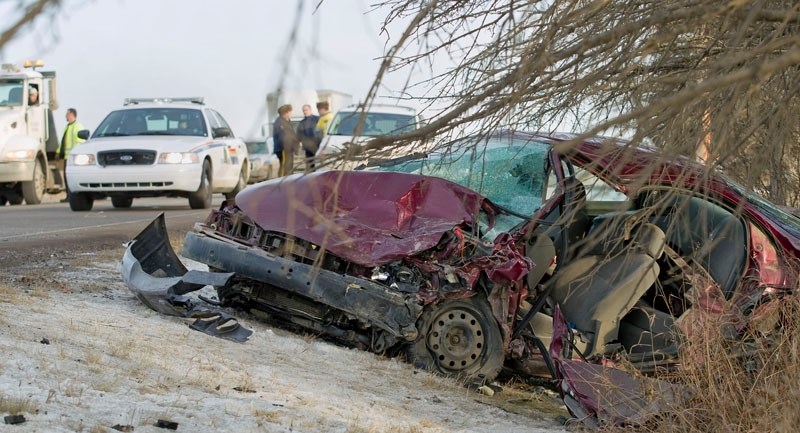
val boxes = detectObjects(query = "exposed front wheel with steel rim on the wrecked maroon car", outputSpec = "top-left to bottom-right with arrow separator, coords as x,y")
406,295 -> 505,380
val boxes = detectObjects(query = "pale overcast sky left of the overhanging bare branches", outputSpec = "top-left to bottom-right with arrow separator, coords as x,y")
0,0 -> 412,136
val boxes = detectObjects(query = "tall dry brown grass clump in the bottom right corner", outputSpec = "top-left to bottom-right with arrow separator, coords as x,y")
608,297 -> 800,432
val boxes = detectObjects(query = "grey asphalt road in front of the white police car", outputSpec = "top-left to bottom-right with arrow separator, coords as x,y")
0,194 -> 224,270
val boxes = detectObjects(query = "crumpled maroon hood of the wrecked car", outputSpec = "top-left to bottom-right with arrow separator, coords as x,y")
236,171 -> 496,266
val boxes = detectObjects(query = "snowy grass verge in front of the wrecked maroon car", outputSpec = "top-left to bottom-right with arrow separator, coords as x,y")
0,250 -> 566,433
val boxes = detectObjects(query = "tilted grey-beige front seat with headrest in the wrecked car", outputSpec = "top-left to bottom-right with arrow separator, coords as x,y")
550,223 -> 666,356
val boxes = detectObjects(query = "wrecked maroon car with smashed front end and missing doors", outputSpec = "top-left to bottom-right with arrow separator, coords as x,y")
123,133 -> 800,386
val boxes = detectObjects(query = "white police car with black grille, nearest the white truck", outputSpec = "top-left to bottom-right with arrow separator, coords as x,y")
66,98 -> 250,211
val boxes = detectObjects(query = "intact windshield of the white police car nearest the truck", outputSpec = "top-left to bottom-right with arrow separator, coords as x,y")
93,107 -> 208,137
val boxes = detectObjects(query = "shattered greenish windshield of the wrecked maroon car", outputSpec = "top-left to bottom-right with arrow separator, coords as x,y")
380,134 -> 550,235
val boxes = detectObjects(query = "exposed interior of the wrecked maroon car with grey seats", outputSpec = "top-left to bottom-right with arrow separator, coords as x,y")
526,175 -> 748,369
